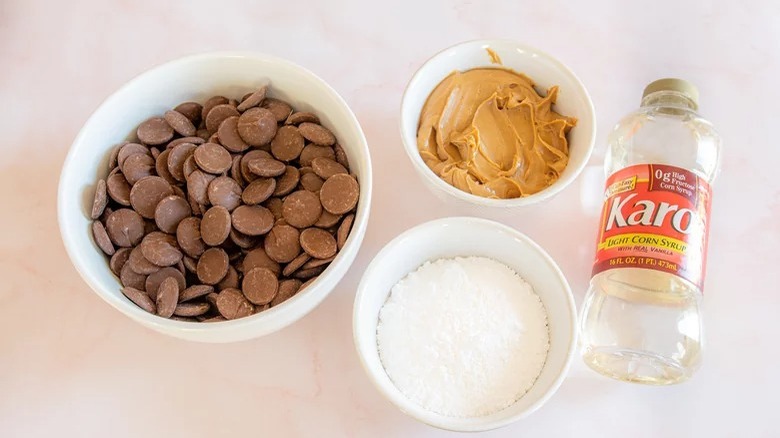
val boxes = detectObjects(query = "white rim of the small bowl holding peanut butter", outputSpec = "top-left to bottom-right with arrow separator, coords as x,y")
398,38 -> 597,208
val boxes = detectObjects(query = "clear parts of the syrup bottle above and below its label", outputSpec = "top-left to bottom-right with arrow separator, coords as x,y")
580,92 -> 720,385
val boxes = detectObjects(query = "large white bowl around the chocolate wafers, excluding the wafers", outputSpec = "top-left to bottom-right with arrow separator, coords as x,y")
57,53 -> 371,342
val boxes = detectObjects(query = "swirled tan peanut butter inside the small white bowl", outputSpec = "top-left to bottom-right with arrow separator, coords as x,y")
417,68 -> 577,199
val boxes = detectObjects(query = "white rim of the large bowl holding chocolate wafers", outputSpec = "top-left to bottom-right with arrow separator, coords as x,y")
57,51 -> 373,342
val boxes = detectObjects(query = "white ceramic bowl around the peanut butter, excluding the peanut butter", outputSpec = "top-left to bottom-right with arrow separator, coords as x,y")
401,39 -> 596,208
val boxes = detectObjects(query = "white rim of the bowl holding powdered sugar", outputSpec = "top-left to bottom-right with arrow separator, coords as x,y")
352,216 -> 578,432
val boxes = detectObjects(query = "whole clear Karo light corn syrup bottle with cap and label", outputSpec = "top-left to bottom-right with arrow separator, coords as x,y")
580,79 -> 720,385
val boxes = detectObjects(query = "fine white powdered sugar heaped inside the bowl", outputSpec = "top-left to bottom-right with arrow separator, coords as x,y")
377,257 -> 549,417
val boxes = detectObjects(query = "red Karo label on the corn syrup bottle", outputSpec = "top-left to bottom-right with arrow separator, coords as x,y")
593,164 -> 712,290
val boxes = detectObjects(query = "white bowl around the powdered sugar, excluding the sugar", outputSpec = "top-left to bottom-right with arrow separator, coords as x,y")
352,217 -> 577,432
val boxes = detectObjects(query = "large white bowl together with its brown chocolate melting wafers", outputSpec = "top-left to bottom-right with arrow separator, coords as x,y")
58,53 -> 371,342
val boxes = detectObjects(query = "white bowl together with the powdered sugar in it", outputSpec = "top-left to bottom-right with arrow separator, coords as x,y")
353,217 -> 576,431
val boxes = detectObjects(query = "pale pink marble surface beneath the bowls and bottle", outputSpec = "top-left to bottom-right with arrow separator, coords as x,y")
0,0 -> 780,437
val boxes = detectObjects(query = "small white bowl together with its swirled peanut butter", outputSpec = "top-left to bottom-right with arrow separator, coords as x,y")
401,40 -> 596,207
